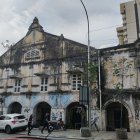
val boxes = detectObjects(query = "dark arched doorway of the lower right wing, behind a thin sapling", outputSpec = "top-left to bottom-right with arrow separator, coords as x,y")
106,102 -> 129,131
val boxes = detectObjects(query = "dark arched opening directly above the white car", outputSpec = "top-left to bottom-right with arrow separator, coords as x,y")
7,102 -> 22,114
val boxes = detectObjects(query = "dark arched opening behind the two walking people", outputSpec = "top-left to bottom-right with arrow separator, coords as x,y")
33,102 -> 51,127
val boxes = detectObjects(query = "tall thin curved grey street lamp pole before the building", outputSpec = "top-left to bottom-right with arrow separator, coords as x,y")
80,0 -> 91,127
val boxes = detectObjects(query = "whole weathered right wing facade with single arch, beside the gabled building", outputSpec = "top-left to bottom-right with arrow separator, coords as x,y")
100,40 -> 140,131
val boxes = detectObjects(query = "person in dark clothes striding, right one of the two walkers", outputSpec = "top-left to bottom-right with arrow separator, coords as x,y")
41,113 -> 51,134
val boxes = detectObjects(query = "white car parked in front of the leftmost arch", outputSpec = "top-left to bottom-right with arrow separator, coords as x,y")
0,113 -> 28,134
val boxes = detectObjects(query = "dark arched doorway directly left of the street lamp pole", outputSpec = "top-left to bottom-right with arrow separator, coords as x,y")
66,102 -> 86,129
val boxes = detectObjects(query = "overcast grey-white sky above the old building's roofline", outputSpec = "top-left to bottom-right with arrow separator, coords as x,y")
0,0 -> 128,54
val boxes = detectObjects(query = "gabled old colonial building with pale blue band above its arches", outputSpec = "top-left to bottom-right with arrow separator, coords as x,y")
0,18 -> 94,128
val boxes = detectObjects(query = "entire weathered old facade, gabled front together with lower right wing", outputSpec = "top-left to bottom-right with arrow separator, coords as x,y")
0,18 -> 140,131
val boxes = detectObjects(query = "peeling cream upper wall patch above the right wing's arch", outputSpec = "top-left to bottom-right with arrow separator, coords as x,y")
103,48 -> 137,89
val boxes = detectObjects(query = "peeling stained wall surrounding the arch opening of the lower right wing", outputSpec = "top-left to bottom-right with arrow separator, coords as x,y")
101,42 -> 140,131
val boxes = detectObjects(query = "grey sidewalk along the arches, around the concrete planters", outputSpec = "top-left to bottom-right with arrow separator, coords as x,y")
19,129 -> 140,140
